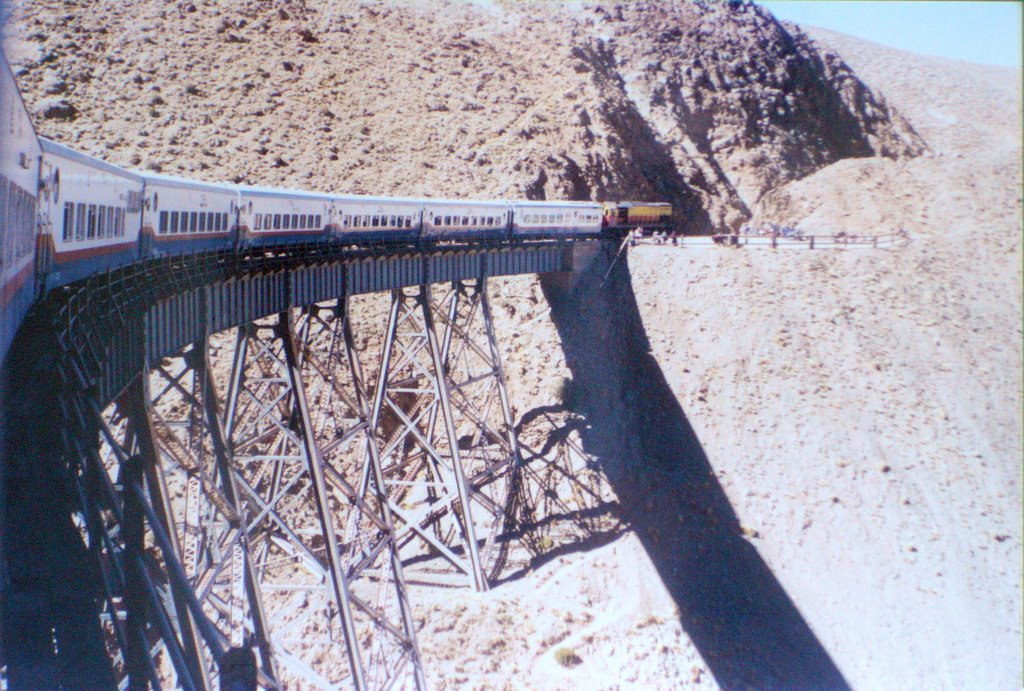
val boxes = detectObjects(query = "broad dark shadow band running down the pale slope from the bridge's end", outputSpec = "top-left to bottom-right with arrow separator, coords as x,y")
543,248 -> 849,689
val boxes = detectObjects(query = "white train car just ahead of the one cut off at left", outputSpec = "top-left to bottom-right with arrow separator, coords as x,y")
39,138 -> 143,288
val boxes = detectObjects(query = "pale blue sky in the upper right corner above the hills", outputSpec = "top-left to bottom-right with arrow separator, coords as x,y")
759,0 -> 1022,68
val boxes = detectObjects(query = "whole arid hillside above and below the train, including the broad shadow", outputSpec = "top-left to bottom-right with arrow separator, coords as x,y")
7,0 -> 1024,689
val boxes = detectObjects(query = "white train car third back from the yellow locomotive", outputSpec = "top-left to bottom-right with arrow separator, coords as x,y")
335,195 -> 423,243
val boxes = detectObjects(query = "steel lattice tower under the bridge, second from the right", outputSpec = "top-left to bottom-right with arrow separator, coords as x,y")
225,309 -> 425,688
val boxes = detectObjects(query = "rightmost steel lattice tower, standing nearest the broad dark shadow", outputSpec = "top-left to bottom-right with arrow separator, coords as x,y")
370,279 -> 521,591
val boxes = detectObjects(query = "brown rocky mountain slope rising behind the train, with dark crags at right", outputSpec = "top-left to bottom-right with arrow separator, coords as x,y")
9,0 -> 926,231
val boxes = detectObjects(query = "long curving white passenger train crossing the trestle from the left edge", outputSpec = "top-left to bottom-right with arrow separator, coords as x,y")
0,51 -> 671,359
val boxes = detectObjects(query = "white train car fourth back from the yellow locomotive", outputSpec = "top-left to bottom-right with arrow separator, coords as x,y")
238,187 -> 337,246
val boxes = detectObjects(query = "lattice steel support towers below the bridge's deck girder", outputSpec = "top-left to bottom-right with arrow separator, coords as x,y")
52,278 -> 521,689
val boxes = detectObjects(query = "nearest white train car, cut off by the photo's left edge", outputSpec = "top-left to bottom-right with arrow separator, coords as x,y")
0,50 -> 40,362
